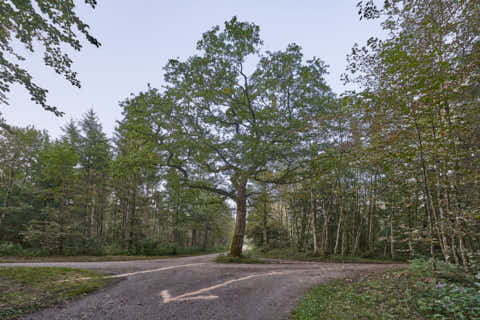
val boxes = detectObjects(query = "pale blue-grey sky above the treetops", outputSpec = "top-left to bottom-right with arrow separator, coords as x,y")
0,0 -> 382,136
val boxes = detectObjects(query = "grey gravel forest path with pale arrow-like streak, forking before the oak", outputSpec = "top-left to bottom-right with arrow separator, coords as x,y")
2,255 -> 404,320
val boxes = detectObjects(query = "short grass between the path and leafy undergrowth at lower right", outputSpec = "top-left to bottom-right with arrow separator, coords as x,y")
293,271 -> 423,320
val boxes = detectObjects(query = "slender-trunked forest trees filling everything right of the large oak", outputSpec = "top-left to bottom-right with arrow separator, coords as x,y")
248,0 -> 480,268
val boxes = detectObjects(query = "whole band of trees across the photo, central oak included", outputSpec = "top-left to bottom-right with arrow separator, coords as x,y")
0,0 -> 480,269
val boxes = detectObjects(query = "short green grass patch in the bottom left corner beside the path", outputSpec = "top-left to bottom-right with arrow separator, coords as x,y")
0,267 -> 110,319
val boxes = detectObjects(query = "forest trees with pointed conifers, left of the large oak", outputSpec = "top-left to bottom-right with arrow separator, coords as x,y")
0,110 -> 232,255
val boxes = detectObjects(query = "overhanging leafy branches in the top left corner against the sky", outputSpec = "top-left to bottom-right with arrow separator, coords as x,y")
0,0 -> 100,116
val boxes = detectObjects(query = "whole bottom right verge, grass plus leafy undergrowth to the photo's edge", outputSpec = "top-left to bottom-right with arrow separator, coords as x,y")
292,261 -> 480,320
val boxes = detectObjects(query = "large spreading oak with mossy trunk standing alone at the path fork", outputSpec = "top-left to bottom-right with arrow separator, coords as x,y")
124,17 -> 333,256
